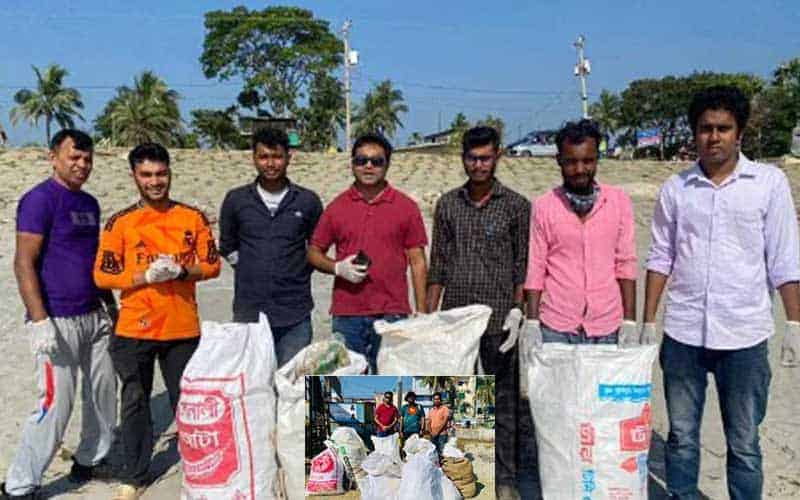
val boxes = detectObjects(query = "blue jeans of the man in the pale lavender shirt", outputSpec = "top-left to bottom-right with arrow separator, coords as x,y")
659,335 -> 771,500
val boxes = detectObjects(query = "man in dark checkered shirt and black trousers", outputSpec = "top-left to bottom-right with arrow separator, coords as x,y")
427,127 -> 531,500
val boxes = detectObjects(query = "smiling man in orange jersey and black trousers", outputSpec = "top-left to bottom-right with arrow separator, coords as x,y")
94,144 -> 220,500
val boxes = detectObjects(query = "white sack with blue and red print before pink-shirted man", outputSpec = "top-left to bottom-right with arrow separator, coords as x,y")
527,343 -> 658,500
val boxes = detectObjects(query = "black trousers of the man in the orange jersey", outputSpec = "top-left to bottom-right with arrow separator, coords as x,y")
109,335 -> 199,486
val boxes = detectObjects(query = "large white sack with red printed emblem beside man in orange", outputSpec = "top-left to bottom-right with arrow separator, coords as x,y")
180,314 -> 277,499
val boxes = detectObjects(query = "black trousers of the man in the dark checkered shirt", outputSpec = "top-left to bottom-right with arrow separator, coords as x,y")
480,331 -> 520,486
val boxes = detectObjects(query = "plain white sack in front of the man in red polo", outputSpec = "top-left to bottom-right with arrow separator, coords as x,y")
374,305 -> 492,375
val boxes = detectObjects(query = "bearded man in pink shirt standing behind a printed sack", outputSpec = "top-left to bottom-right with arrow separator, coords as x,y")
521,120 -> 639,354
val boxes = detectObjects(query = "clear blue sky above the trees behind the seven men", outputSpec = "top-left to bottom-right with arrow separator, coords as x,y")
0,0 -> 800,144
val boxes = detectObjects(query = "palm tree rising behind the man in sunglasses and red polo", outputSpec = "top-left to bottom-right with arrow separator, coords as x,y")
355,80 -> 408,137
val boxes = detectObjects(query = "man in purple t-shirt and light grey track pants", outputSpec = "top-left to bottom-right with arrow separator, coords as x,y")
2,129 -> 116,498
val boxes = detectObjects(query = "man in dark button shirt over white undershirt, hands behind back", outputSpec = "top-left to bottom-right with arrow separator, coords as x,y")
219,129 -> 322,366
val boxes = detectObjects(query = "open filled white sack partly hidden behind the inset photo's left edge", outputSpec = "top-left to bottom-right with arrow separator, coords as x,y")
275,341 -> 367,500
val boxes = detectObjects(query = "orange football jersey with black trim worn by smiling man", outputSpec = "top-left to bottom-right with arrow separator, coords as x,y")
94,202 -> 220,340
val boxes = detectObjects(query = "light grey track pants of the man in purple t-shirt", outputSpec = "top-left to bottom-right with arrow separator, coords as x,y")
6,309 -> 117,495
